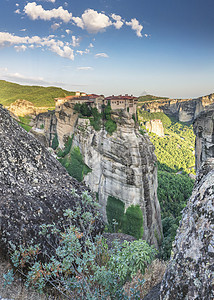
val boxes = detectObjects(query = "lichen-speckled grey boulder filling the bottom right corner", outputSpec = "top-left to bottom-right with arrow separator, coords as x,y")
160,158 -> 214,300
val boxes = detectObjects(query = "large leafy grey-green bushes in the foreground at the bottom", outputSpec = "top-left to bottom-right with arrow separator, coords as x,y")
8,190 -> 156,300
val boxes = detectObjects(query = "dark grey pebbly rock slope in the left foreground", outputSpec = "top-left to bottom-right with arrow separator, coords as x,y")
0,107 -> 103,253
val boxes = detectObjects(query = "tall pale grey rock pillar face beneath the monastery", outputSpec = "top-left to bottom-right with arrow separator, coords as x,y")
73,111 -> 162,245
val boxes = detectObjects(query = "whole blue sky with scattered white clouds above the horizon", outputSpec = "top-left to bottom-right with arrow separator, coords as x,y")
0,0 -> 214,98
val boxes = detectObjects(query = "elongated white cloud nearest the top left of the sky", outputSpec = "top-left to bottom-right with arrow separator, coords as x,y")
24,2 -> 72,23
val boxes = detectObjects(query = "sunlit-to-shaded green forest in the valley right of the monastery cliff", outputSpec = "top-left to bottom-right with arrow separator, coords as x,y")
138,109 -> 195,259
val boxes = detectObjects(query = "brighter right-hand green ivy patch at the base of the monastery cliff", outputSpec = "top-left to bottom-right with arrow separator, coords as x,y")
122,205 -> 143,239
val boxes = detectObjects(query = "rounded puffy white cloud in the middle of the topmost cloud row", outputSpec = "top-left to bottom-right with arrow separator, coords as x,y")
73,9 -> 112,33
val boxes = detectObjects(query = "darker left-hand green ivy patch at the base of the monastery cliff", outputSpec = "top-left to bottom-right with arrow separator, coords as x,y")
106,196 -> 125,232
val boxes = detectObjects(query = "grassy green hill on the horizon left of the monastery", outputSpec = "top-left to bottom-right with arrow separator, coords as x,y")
0,80 -> 74,107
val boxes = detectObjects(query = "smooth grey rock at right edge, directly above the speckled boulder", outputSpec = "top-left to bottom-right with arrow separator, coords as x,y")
193,105 -> 214,170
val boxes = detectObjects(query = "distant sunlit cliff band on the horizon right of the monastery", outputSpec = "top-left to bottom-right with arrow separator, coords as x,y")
141,94 -> 214,122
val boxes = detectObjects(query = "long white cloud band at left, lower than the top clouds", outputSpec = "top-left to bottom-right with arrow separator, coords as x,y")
0,32 -> 74,60
